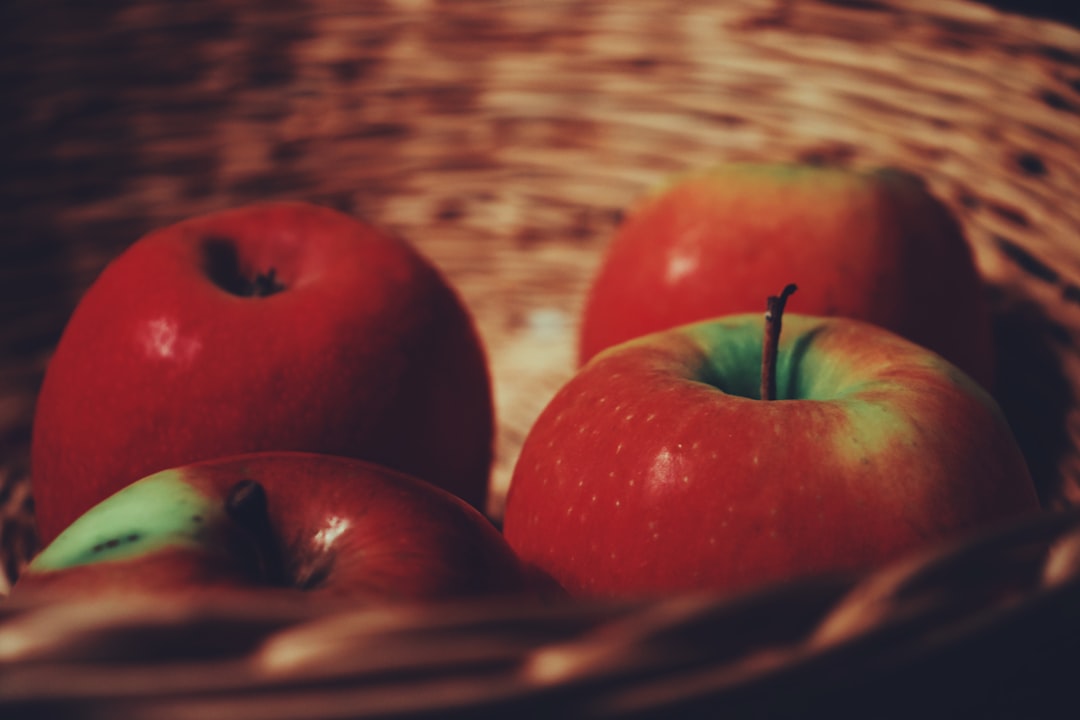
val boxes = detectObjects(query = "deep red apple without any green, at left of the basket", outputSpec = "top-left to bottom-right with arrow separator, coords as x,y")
31,203 -> 494,542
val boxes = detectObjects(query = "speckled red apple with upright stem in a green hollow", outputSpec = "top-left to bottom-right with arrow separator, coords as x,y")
503,313 -> 1039,596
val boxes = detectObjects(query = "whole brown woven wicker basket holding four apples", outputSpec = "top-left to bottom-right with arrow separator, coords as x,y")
0,0 -> 1080,720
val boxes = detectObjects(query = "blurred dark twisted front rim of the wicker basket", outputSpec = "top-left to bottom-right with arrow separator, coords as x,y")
0,512 -> 1080,720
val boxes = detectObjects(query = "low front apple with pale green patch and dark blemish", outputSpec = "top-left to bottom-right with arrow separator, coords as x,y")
12,452 -> 550,602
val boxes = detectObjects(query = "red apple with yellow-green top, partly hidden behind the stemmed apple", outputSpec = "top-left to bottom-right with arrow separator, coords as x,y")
579,163 -> 994,389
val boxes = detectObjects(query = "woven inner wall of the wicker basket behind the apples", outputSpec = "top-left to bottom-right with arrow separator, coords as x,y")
0,0 -> 1080,716
